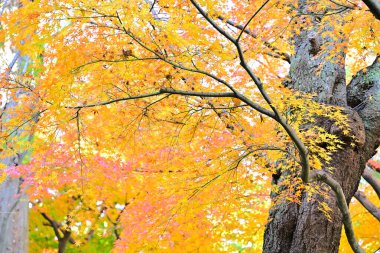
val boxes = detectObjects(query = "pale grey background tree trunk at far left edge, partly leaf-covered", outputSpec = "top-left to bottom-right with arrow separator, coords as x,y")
0,1 -> 28,253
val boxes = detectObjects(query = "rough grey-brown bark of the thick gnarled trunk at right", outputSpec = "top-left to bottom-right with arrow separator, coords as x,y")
263,0 -> 380,253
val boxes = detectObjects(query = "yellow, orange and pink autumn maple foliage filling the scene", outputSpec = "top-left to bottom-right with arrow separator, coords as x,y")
1,0 -> 380,252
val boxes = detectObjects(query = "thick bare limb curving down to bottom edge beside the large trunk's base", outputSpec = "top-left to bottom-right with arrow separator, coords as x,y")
310,171 -> 365,253
